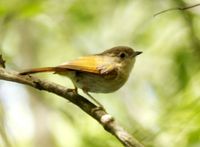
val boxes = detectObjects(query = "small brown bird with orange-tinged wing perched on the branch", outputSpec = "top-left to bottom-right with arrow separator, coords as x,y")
20,46 -> 142,105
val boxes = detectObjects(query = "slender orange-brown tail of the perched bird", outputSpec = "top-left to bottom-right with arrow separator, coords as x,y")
19,67 -> 59,75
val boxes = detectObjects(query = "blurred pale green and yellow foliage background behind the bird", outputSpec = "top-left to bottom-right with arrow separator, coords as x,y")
0,0 -> 200,147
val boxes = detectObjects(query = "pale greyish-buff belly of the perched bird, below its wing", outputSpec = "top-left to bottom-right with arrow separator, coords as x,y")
73,73 -> 126,93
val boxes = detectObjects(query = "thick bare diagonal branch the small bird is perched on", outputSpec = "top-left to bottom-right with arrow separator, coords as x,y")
0,55 -> 143,147
